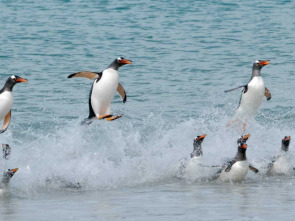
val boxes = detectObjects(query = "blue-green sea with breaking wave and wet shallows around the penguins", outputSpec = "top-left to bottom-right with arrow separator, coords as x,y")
0,0 -> 295,221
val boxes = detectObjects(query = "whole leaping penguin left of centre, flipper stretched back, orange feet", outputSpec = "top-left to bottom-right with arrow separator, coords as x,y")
68,57 -> 132,121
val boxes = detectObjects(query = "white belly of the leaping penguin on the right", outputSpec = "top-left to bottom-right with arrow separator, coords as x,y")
234,76 -> 265,122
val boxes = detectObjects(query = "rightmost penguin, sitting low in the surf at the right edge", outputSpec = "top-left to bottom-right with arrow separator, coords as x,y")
267,136 -> 293,175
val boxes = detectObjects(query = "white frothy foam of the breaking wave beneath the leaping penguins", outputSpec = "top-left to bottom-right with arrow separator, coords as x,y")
3,106 -> 295,193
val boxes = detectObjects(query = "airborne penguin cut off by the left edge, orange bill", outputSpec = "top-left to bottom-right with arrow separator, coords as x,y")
0,75 -> 28,133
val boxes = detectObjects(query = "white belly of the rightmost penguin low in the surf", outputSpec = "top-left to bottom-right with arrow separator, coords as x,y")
268,155 -> 293,175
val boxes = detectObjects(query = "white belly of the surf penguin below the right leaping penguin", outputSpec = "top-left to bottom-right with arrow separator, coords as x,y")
218,160 -> 249,182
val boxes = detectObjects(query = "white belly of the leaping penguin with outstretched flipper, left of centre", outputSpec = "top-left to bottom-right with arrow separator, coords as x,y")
91,69 -> 119,117
